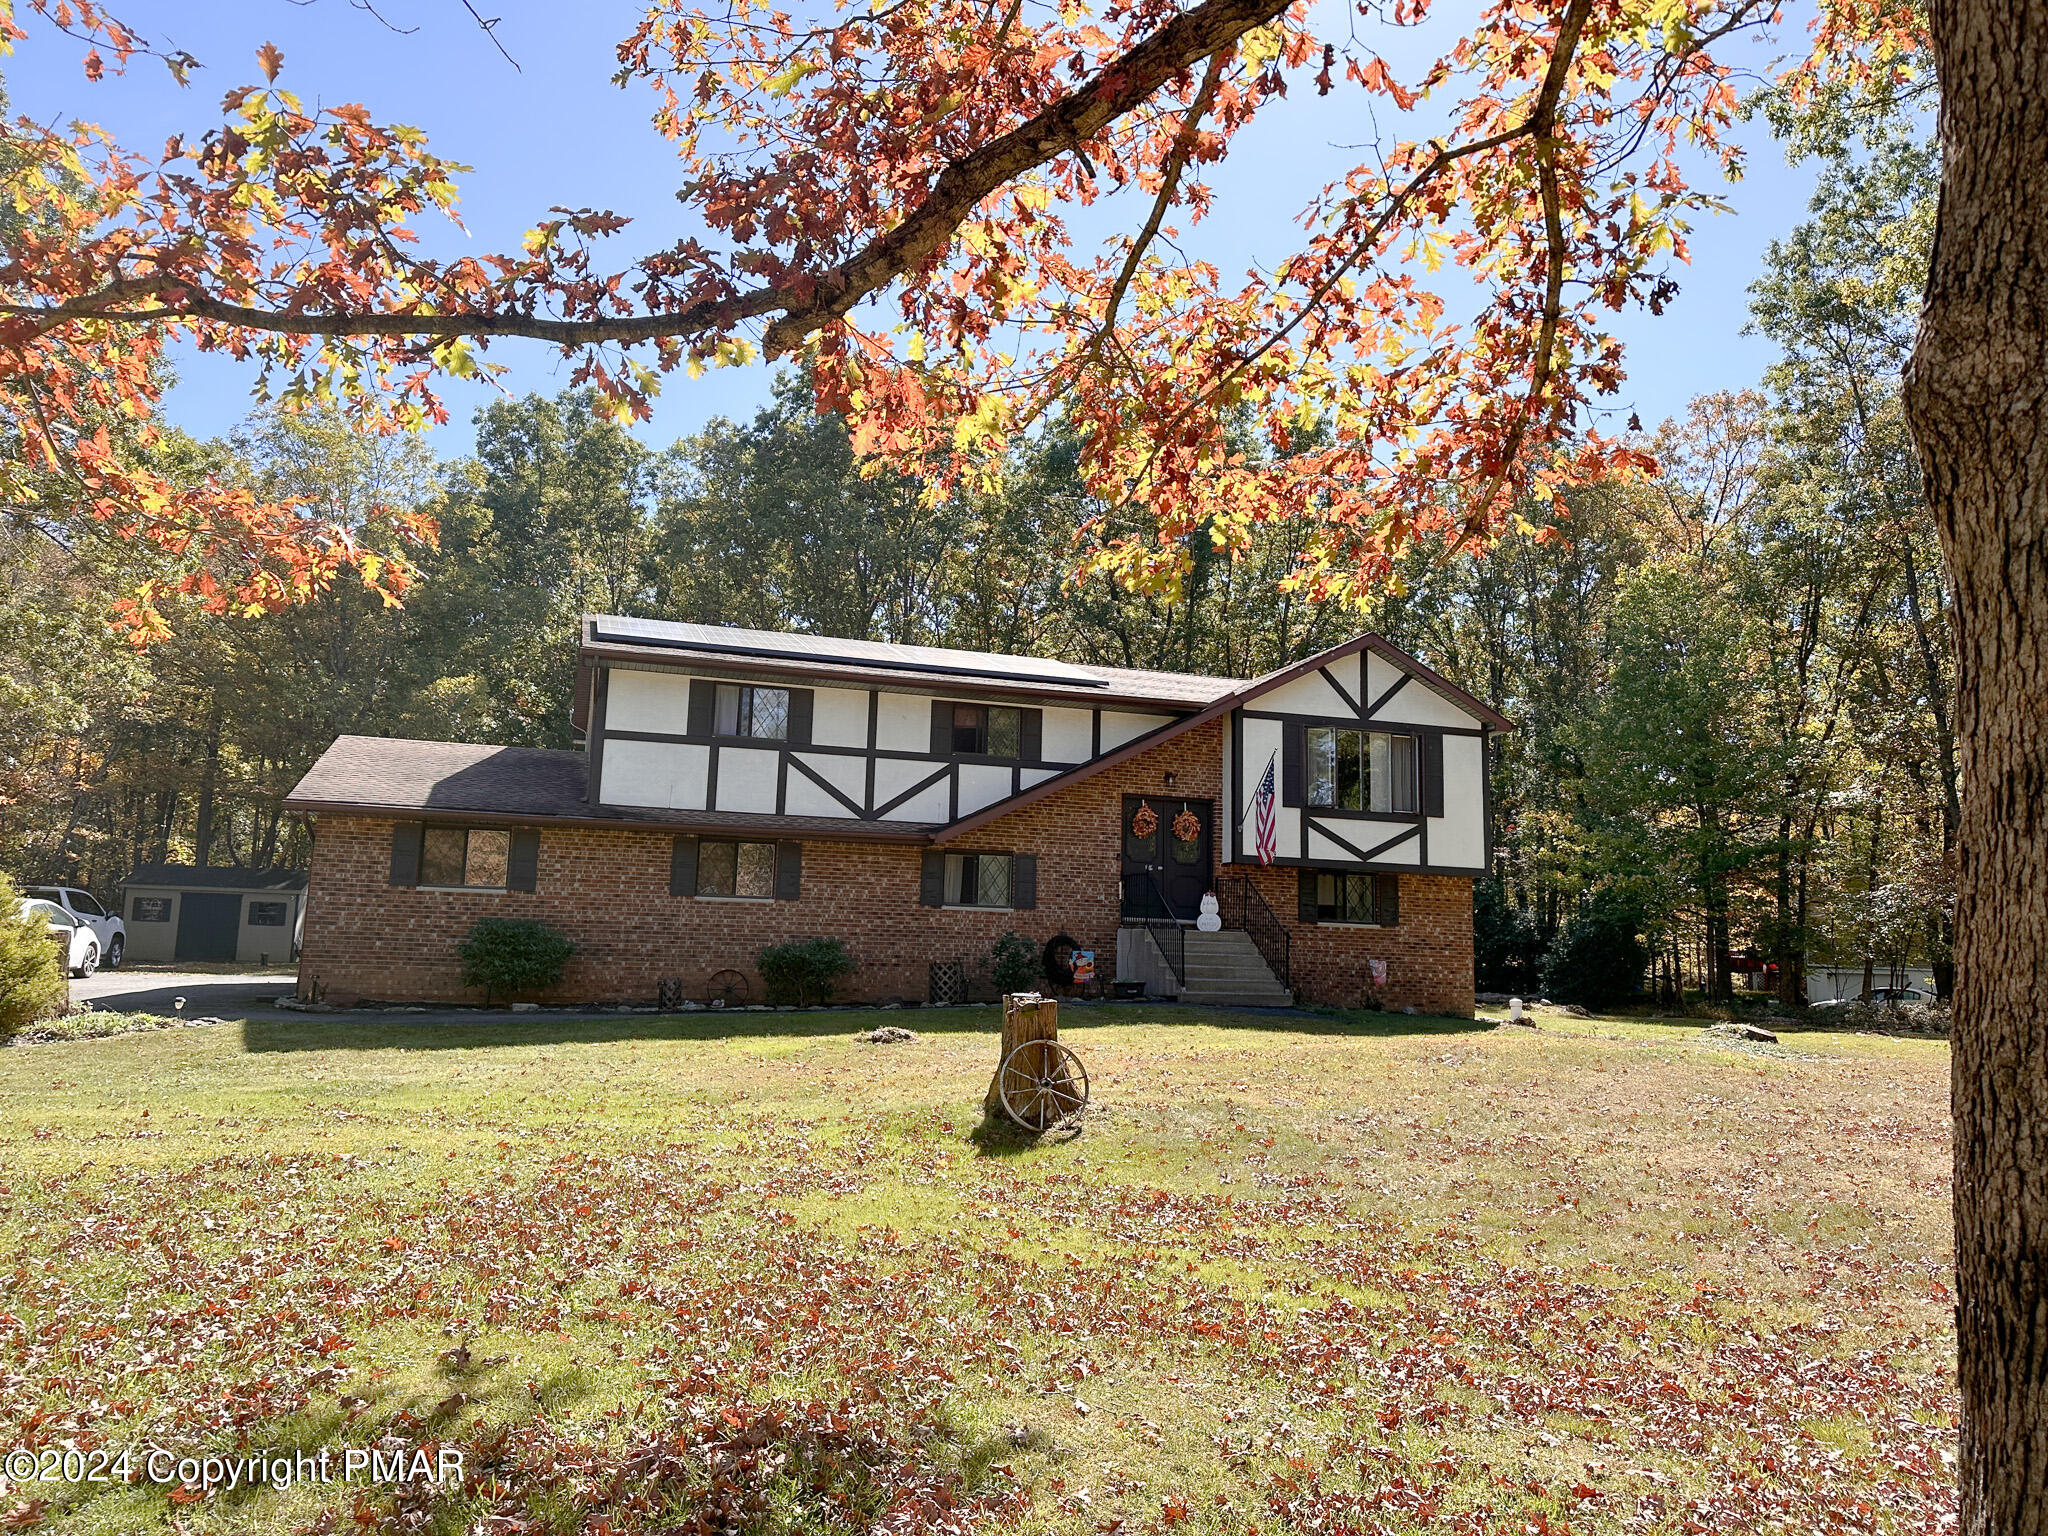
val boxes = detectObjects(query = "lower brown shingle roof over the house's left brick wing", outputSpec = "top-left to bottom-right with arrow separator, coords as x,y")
285,735 -> 932,842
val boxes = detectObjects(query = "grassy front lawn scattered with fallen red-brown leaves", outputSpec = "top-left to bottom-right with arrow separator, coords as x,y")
0,1008 -> 1956,1536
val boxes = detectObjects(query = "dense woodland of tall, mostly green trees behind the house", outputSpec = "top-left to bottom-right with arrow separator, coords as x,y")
0,123 -> 1958,999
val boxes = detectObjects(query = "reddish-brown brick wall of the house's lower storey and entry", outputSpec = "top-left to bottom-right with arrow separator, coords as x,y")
299,725 -> 1473,1014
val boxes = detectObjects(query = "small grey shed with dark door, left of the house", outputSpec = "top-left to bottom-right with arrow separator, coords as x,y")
121,864 -> 305,965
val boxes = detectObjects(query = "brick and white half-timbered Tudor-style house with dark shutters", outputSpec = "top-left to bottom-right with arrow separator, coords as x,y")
287,616 -> 1511,1014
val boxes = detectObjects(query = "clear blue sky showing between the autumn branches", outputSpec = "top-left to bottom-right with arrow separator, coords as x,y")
6,0 -> 1815,455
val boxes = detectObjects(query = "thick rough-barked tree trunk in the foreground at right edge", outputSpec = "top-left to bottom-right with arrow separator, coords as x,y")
1907,0 -> 2048,1536
